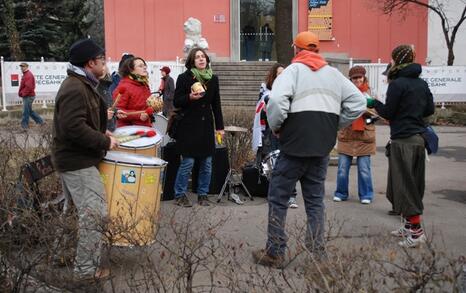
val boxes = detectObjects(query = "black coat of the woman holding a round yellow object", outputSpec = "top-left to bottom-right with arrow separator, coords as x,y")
174,70 -> 223,157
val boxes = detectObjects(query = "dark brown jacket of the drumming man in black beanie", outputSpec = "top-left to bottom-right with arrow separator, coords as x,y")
52,70 -> 110,172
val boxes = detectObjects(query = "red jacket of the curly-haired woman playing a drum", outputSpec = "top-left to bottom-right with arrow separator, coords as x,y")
113,77 -> 151,127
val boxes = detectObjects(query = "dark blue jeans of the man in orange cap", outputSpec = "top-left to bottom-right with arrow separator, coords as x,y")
266,153 -> 329,256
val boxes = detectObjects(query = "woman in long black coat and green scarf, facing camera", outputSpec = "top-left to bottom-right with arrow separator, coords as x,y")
174,48 -> 224,207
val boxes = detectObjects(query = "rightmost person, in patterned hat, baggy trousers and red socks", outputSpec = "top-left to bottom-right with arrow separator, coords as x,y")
375,45 -> 435,247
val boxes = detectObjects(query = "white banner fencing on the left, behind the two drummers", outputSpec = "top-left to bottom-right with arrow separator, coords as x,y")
2,61 -> 185,106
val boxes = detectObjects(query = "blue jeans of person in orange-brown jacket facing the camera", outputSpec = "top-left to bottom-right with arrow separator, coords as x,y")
335,154 -> 374,200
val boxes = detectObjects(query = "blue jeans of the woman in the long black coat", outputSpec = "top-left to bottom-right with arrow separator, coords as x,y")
175,156 -> 212,198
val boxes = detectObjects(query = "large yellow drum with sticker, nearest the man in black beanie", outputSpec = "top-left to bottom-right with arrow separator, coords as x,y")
99,151 -> 167,246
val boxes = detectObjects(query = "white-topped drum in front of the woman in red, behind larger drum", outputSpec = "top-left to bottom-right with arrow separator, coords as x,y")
113,125 -> 162,157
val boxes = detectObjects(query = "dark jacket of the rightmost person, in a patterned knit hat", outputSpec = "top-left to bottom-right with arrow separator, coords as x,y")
375,63 -> 435,139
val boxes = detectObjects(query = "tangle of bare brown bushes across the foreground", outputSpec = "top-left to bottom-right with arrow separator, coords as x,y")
0,119 -> 465,292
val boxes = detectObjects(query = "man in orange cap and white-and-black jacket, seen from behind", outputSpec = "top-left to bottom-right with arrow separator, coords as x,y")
253,32 -> 366,267
